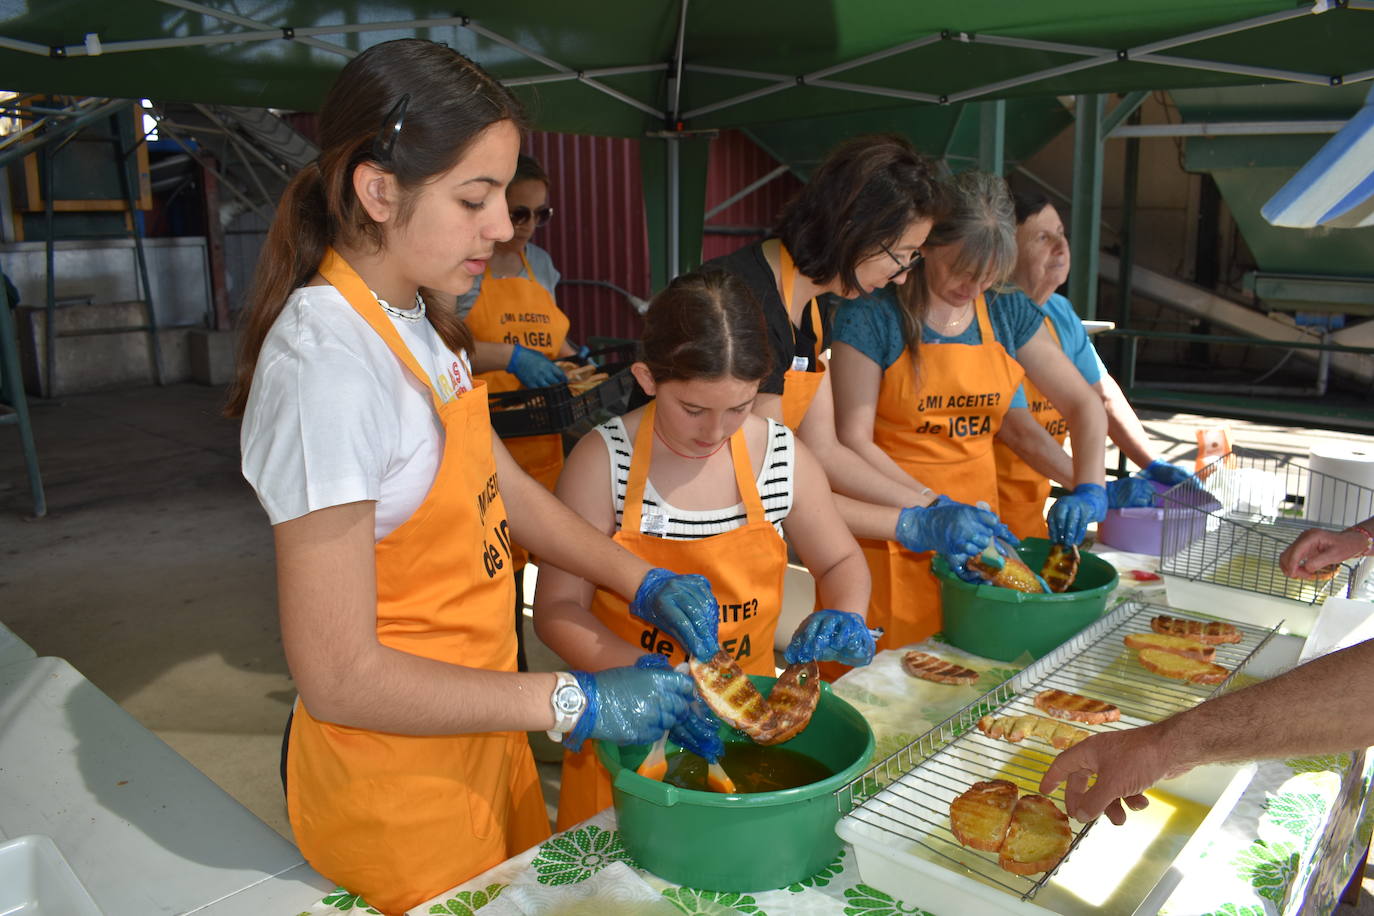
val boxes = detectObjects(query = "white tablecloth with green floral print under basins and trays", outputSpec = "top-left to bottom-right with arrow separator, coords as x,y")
293,552 -> 1374,916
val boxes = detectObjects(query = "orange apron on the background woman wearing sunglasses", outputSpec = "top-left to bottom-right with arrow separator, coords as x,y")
464,251 -> 569,569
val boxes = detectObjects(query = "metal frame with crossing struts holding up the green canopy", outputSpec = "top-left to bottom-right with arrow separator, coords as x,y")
0,0 -> 1374,287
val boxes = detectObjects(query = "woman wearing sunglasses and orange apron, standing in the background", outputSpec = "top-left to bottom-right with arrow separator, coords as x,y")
458,155 -> 577,672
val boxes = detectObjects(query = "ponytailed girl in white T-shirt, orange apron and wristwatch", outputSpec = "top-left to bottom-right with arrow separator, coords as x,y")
225,38 -> 719,913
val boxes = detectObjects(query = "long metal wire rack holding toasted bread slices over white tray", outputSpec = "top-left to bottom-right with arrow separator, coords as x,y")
835,602 -> 1276,900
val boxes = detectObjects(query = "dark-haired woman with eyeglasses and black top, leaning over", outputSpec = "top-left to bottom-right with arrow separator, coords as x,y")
706,135 -> 998,659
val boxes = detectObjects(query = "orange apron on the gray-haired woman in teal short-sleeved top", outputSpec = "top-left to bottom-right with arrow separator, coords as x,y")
859,295 -> 1025,650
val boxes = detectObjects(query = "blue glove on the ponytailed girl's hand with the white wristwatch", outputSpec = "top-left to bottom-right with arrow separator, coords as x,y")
563,667 -> 697,751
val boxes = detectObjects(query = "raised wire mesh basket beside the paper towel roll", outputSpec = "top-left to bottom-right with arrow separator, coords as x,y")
1160,449 -> 1374,604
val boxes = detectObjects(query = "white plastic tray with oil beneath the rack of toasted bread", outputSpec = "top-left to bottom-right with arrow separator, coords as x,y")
835,603 -> 1301,916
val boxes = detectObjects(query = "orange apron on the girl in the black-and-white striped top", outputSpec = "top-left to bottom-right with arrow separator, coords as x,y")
558,401 -> 787,829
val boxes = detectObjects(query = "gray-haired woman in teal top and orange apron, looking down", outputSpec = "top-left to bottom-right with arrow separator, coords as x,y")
833,172 -> 1106,647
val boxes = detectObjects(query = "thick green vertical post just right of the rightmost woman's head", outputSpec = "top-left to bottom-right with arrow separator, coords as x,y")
1069,93 -> 1105,319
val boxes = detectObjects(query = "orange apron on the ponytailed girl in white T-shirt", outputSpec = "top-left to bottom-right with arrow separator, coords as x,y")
286,249 -> 548,913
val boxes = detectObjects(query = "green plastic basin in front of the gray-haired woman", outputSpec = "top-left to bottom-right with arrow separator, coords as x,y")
930,537 -> 1117,662
